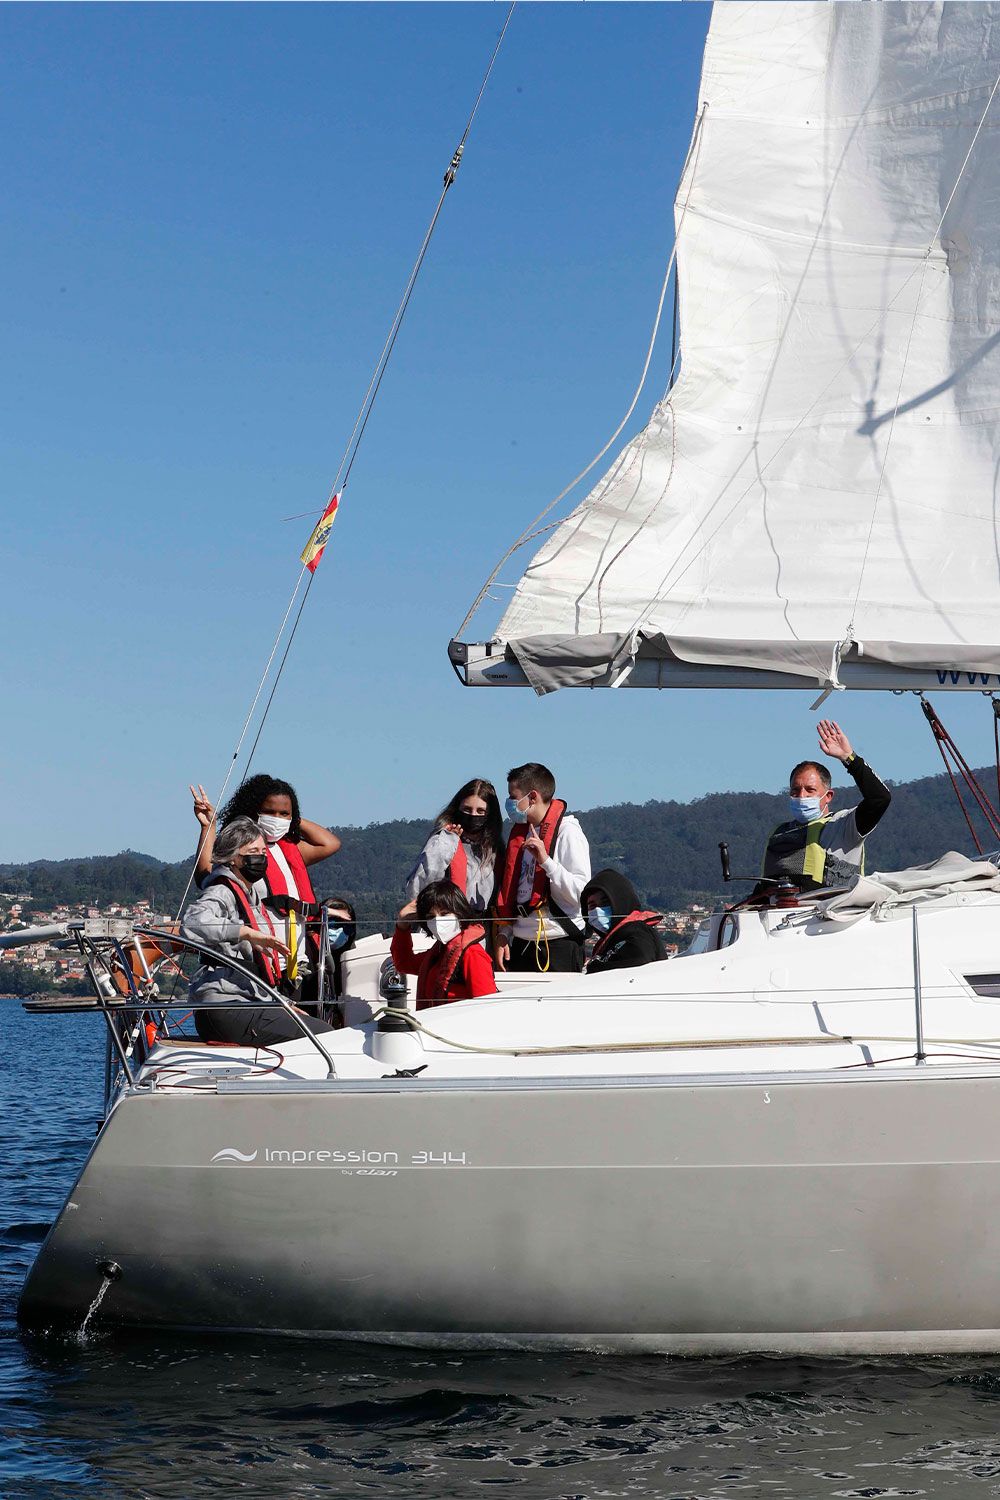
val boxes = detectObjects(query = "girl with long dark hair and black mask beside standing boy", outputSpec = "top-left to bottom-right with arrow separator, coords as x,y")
406,777 -> 504,914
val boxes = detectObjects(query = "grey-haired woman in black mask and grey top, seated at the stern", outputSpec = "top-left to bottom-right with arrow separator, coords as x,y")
180,818 -> 333,1047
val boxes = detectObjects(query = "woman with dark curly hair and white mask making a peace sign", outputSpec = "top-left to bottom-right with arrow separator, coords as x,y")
190,773 -> 340,993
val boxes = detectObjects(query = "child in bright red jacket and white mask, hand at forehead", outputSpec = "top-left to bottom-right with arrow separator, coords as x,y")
391,881 -> 496,1011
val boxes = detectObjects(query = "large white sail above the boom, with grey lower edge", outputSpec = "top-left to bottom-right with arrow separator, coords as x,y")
458,3 -> 1000,692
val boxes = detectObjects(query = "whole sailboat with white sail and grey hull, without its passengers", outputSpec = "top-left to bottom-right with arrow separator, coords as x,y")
15,3 -> 1000,1353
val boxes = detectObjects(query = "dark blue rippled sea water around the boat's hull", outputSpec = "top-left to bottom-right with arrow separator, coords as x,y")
0,1001 -> 1000,1500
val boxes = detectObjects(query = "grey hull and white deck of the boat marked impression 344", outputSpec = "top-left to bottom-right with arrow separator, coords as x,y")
21,870 -> 1000,1355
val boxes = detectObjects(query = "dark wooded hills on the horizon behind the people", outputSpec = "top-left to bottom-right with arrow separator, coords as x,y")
0,768 -> 996,923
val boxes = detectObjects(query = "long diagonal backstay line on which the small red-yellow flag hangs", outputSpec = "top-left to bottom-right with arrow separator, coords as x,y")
177,0 -> 517,918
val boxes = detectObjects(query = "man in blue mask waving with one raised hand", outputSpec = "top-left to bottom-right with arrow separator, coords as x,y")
754,719 -> 892,894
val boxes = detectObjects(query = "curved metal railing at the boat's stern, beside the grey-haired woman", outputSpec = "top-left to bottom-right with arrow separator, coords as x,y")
0,909 -> 336,1113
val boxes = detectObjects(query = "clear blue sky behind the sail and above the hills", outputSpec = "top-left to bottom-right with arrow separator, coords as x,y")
0,3 -> 991,860
